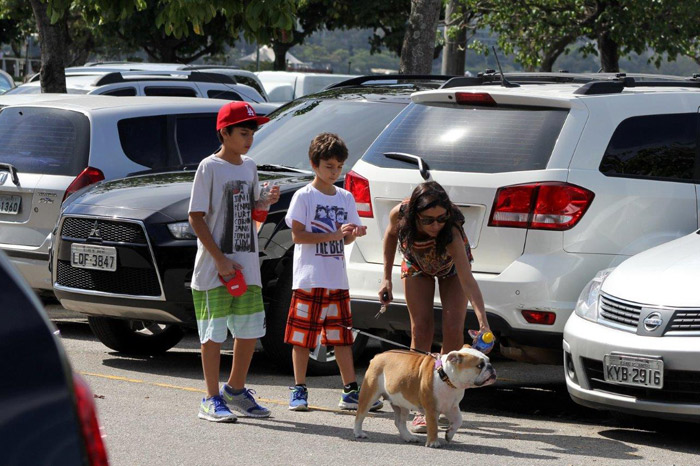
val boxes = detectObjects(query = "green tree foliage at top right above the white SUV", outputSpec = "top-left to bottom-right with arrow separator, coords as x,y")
462,0 -> 700,69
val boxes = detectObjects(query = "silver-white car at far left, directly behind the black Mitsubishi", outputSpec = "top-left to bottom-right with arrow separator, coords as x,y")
0,95 -> 268,292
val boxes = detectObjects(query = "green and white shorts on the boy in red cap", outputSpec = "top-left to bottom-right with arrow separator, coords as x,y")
192,286 -> 265,344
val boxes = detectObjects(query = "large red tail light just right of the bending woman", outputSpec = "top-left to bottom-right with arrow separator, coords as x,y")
489,182 -> 595,231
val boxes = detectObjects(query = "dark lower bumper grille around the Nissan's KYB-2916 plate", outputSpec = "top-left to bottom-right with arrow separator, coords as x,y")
581,358 -> 700,403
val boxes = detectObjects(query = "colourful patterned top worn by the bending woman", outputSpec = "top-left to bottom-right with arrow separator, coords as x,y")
399,200 -> 474,278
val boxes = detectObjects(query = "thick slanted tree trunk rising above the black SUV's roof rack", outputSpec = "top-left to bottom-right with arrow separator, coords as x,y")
399,0 -> 442,74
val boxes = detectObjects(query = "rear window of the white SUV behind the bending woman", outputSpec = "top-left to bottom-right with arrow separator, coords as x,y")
362,104 -> 568,173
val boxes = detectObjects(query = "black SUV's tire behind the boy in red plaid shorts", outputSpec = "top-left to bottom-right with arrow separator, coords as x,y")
261,261 -> 367,375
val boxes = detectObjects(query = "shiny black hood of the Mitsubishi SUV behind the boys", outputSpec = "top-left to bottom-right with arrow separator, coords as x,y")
64,171 -> 313,220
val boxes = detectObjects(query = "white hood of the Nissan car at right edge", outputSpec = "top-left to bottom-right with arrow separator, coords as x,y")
602,233 -> 700,307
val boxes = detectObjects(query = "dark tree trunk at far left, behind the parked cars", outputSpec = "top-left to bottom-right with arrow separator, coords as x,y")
27,0 -> 67,94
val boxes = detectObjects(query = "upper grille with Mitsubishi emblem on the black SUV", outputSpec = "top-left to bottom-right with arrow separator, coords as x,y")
61,217 -> 146,244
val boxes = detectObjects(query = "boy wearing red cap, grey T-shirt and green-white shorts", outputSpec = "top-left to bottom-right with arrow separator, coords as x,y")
189,102 -> 279,422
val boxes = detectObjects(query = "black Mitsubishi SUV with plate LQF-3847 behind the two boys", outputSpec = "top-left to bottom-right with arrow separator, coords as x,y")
52,75 -> 454,374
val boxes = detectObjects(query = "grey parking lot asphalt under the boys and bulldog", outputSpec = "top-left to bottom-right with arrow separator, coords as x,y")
49,308 -> 700,465
